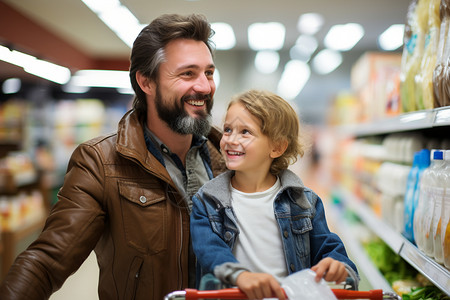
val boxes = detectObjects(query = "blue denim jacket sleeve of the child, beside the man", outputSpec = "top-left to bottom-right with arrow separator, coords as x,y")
190,194 -> 238,274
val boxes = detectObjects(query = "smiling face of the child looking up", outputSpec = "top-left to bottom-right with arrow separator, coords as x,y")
220,103 -> 273,172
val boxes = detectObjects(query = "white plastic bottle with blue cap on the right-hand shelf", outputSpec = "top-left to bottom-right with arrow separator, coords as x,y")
413,149 -> 432,249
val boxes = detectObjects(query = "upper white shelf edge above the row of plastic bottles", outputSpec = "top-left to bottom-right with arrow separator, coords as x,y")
339,106 -> 450,136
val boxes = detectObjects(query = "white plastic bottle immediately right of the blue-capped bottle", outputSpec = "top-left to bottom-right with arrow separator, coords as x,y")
431,151 -> 450,264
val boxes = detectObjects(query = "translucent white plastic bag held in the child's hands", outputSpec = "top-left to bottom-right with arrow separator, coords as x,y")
281,269 -> 337,300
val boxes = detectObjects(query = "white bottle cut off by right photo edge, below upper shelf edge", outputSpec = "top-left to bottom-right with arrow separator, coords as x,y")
441,150 -> 450,269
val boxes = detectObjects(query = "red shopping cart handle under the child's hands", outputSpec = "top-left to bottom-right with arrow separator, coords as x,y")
164,288 -> 402,300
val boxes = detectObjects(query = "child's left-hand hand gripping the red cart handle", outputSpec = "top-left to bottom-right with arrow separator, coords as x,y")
236,271 -> 286,300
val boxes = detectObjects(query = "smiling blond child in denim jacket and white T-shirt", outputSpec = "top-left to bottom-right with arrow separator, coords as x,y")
191,90 -> 359,300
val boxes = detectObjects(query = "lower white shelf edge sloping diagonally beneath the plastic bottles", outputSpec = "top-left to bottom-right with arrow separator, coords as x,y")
339,191 -> 450,295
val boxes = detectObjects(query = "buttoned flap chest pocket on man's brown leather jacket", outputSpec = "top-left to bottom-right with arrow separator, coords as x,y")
118,181 -> 168,254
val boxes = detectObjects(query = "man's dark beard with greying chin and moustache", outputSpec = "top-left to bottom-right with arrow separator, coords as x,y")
155,88 -> 212,136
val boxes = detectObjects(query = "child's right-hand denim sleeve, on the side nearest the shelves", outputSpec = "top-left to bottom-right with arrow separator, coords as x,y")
310,197 -> 359,282
